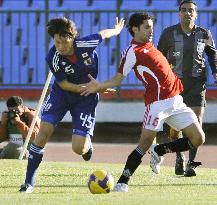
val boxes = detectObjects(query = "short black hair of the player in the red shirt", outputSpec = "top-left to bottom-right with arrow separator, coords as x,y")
127,12 -> 154,37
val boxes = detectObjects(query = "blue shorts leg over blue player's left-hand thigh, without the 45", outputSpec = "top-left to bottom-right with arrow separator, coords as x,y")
41,91 -> 68,126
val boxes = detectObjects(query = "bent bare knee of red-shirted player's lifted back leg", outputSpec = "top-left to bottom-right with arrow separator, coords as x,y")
182,122 -> 205,147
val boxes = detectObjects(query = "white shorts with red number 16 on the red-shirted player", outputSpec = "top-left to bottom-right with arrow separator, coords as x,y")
143,95 -> 198,132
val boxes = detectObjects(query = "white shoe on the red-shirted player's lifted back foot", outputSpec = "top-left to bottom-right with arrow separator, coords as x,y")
148,144 -> 164,174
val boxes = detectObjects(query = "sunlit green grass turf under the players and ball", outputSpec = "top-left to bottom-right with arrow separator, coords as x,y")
0,160 -> 217,205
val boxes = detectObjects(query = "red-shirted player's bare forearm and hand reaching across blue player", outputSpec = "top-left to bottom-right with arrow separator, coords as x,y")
80,73 -> 124,96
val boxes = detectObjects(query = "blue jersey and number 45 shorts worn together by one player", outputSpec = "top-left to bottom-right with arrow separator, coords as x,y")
41,34 -> 102,137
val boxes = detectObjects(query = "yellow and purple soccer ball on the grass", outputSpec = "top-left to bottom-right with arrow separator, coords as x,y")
88,170 -> 114,194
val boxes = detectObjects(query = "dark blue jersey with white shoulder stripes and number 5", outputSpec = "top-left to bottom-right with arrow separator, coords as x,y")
46,34 -> 102,89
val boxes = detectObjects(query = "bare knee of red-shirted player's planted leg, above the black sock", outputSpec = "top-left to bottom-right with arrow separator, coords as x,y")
138,128 -> 157,153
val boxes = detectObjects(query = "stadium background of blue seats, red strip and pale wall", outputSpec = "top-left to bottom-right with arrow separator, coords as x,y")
0,0 -> 217,143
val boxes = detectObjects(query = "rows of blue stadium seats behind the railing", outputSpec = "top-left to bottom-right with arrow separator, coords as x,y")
0,0 -> 217,88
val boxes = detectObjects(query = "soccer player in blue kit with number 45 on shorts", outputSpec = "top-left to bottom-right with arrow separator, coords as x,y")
20,18 -> 124,193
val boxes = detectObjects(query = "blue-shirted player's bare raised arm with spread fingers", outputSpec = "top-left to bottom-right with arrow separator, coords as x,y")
99,17 -> 124,39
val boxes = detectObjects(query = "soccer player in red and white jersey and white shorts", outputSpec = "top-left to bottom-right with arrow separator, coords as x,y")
81,13 -> 205,192
